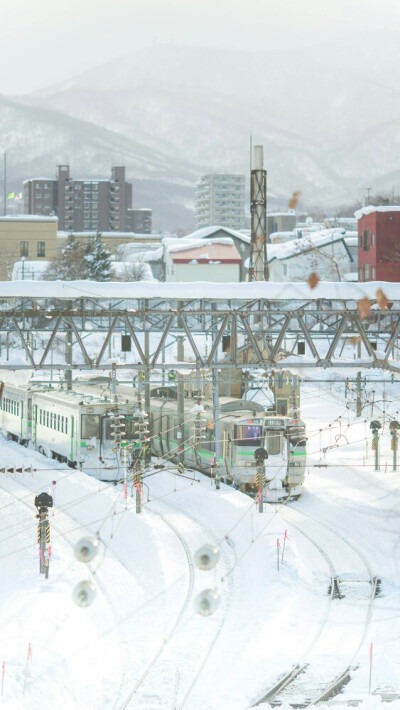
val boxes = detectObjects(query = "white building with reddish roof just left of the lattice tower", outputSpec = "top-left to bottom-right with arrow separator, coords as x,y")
164,238 -> 242,283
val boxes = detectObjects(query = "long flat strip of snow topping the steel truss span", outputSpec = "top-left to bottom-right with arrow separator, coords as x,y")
0,281 -> 400,302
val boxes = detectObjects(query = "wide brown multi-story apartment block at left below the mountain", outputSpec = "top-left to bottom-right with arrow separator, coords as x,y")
24,165 -> 132,232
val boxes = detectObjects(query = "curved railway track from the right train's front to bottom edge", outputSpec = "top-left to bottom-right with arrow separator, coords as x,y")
252,508 -> 378,708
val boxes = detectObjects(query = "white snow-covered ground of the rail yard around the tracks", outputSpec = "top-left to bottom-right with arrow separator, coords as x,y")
0,382 -> 400,710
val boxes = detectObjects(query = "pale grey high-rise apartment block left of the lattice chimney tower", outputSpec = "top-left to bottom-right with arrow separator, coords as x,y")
195,174 -> 245,230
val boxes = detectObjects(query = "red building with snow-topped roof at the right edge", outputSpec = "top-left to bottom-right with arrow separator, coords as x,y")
355,206 -> 400,281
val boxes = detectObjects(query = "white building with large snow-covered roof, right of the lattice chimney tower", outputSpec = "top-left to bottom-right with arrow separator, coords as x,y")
268,229 -> 354,282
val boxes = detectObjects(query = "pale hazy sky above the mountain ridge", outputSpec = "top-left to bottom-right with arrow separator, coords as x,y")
0,0 -> 400,93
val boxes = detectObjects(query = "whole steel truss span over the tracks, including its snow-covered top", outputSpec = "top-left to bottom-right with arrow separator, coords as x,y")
0,281 -> 400,373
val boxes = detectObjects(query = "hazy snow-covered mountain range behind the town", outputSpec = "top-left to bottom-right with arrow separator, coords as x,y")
4,39 -> 400,227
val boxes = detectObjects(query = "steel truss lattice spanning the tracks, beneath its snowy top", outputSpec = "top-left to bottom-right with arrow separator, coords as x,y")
0,284 -> 400,371
